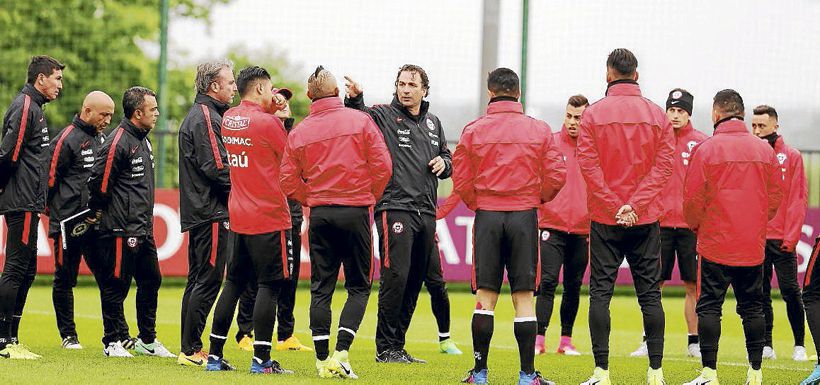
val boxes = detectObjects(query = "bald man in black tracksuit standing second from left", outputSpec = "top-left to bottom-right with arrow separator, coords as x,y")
48,91 -> 114,349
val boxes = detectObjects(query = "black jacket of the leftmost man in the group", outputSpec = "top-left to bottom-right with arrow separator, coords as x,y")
0,84 -> 49,215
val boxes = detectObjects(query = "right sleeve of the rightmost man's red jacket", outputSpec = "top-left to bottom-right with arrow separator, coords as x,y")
783,151 -> 809,250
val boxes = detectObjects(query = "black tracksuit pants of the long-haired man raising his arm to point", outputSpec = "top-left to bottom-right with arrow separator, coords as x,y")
375,210 -> 436,353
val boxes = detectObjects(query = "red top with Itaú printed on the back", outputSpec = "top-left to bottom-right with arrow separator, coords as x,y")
222,100 -> 291,234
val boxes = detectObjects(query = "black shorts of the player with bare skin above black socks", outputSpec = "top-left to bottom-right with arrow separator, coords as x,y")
472,209 -> 541,293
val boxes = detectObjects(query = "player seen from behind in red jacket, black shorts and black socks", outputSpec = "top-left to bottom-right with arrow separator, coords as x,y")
453,68 -> 566,385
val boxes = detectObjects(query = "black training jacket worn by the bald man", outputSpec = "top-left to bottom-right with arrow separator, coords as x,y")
48,115 -> 105,236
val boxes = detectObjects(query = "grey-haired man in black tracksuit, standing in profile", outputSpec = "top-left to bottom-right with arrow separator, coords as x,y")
177,61 -> 236,366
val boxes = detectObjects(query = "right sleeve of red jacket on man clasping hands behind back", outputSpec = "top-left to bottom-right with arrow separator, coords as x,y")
627,117 -> 675,216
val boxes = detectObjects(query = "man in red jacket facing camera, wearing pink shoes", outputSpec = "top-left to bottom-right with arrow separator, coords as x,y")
535,95 -> 589,356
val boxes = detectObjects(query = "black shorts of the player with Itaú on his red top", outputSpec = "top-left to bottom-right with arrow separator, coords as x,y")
228,229 -> 294,285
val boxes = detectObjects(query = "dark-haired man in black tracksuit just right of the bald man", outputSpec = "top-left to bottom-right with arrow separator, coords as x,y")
88,87 -> 176,357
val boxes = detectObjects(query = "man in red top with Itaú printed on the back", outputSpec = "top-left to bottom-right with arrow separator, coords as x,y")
206,66 -> 293,374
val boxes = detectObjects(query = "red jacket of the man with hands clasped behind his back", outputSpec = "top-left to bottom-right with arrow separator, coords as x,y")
578,81 -> 675,225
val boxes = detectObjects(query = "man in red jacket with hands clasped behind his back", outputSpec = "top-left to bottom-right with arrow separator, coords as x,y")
578,48 -> 675,385
